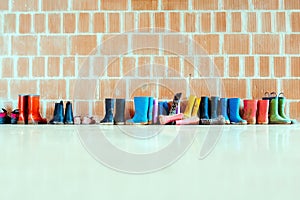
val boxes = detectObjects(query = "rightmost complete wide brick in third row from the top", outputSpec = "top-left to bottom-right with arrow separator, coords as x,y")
253,34 -> 279,54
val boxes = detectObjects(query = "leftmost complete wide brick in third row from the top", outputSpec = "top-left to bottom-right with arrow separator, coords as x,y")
12,36 -> 37,55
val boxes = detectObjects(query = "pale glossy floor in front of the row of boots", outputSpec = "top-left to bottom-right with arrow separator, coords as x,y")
0,125 -> 300,200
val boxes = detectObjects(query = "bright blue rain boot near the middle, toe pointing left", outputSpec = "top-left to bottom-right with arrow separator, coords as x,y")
126,97 -> 149,125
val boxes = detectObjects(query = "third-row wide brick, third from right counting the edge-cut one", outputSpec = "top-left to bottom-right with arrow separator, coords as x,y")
223,34 -> 249,54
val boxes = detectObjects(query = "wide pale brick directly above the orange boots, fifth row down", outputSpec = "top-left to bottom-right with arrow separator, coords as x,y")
9,79 -> 37,99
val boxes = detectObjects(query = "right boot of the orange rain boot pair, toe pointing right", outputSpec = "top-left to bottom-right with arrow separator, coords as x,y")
28,95 -> 47,124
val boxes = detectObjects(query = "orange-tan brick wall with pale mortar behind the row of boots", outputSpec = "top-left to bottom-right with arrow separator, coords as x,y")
0,0 -> 300,119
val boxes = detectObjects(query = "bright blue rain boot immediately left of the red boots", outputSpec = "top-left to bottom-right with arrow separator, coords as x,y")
228,98 -> 247,125
